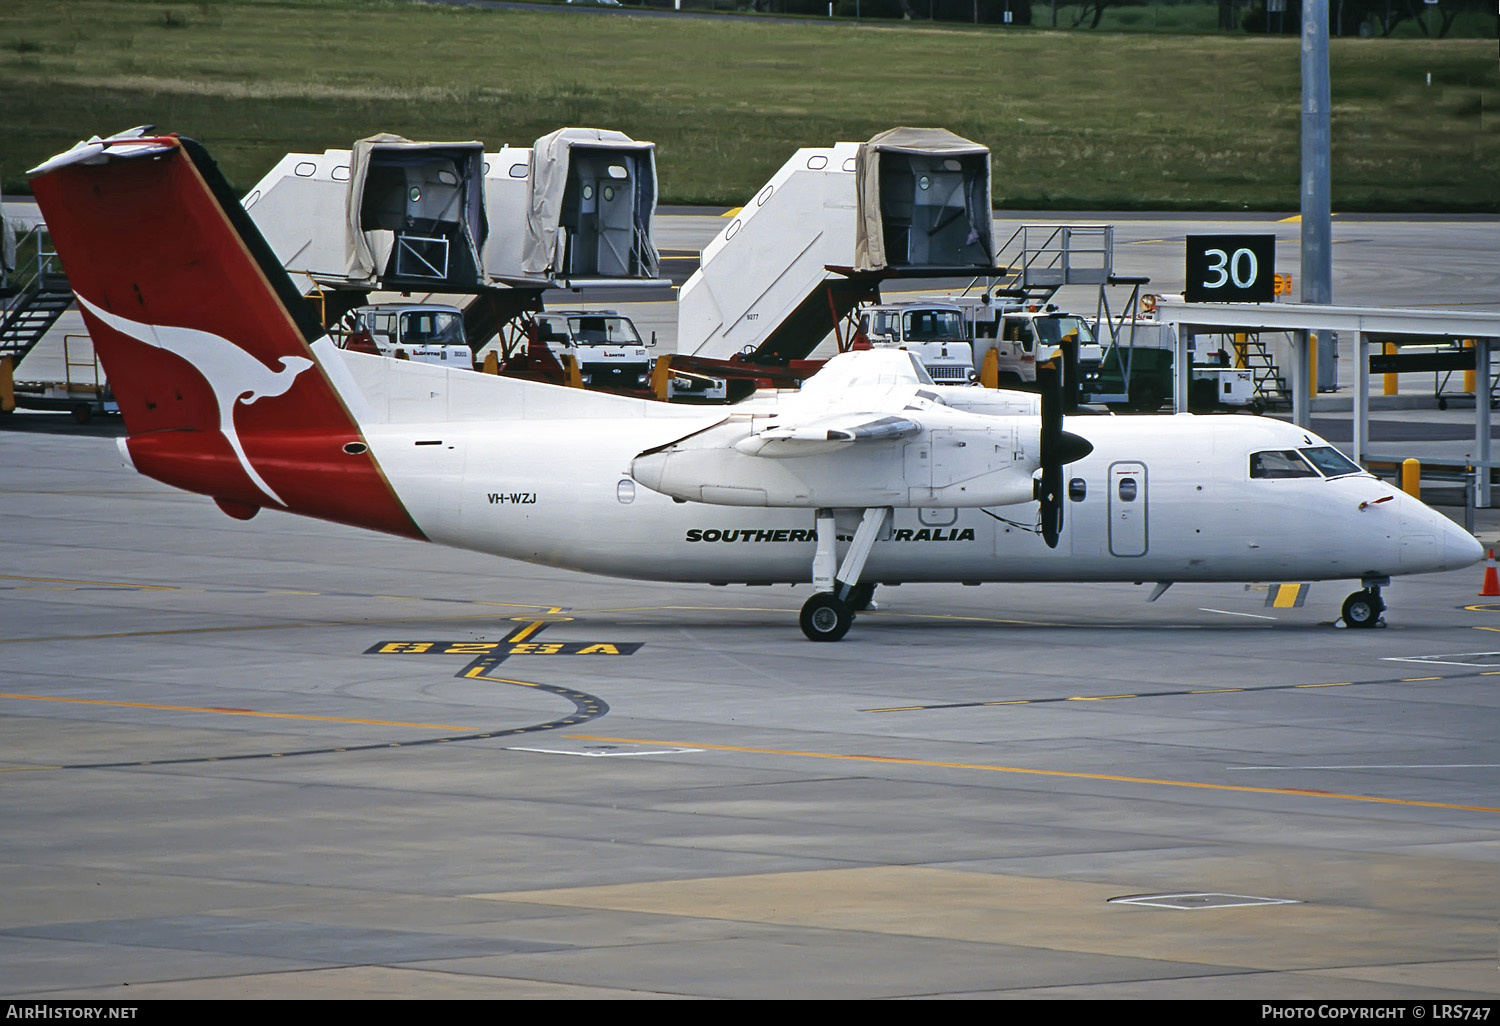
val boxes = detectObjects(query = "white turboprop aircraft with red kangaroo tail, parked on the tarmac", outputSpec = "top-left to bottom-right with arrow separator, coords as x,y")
33,134 -> 1481,641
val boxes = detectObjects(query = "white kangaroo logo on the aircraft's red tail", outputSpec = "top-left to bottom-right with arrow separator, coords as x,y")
78,296 -> 312,506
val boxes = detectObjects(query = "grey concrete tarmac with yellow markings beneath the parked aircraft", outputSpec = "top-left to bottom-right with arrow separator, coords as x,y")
0,429 -> 1500,1001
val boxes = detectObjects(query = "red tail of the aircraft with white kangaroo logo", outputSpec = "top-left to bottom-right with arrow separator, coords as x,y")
33,137 -> 422,537
